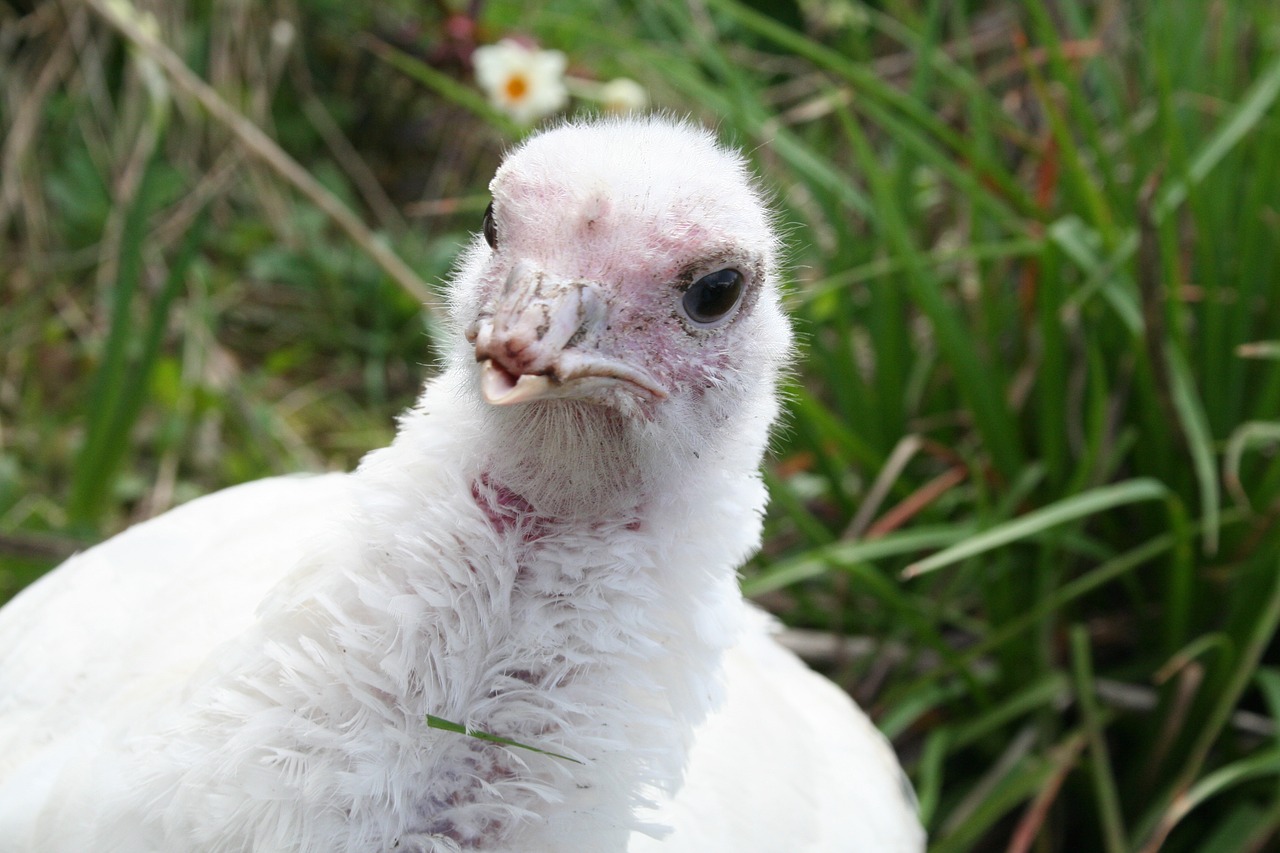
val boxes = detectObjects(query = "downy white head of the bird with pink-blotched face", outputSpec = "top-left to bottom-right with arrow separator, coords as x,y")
451,117 -> 791,517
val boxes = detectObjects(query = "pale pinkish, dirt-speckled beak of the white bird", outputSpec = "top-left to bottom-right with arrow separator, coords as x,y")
467,263 -> 667,406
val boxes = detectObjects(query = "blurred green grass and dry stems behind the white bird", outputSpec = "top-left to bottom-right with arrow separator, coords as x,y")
0,0 -> 1280,853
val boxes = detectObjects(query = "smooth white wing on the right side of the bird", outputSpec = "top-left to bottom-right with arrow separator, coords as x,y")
627,608 -> 924,853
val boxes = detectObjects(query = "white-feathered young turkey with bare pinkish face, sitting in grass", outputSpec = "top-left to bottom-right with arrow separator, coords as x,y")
0,118 -> 924,853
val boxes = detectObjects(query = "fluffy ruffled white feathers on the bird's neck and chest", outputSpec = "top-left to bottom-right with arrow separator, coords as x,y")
85,380 -> 763,850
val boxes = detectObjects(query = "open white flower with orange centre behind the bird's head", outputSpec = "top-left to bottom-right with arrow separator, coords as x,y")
472,38 -> 568,124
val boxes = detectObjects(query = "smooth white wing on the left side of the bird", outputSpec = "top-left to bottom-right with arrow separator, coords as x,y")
0,474 -> 355,849
